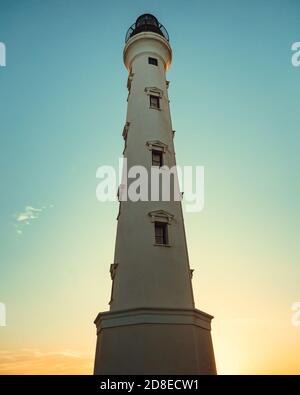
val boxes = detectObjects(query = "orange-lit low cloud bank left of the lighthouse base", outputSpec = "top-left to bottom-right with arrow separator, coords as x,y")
0,349 -> 93,374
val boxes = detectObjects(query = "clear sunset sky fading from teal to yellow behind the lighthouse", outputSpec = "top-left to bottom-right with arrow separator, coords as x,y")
0,0 -> 300,374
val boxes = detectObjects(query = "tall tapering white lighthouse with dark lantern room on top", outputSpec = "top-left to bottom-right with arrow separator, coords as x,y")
94,14 -> 216,375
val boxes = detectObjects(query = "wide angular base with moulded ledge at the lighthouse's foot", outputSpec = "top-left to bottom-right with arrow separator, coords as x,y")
94,308 -> 216,375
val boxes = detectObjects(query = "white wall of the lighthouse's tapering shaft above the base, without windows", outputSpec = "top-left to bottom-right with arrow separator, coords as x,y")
111,32 -> 194,310
